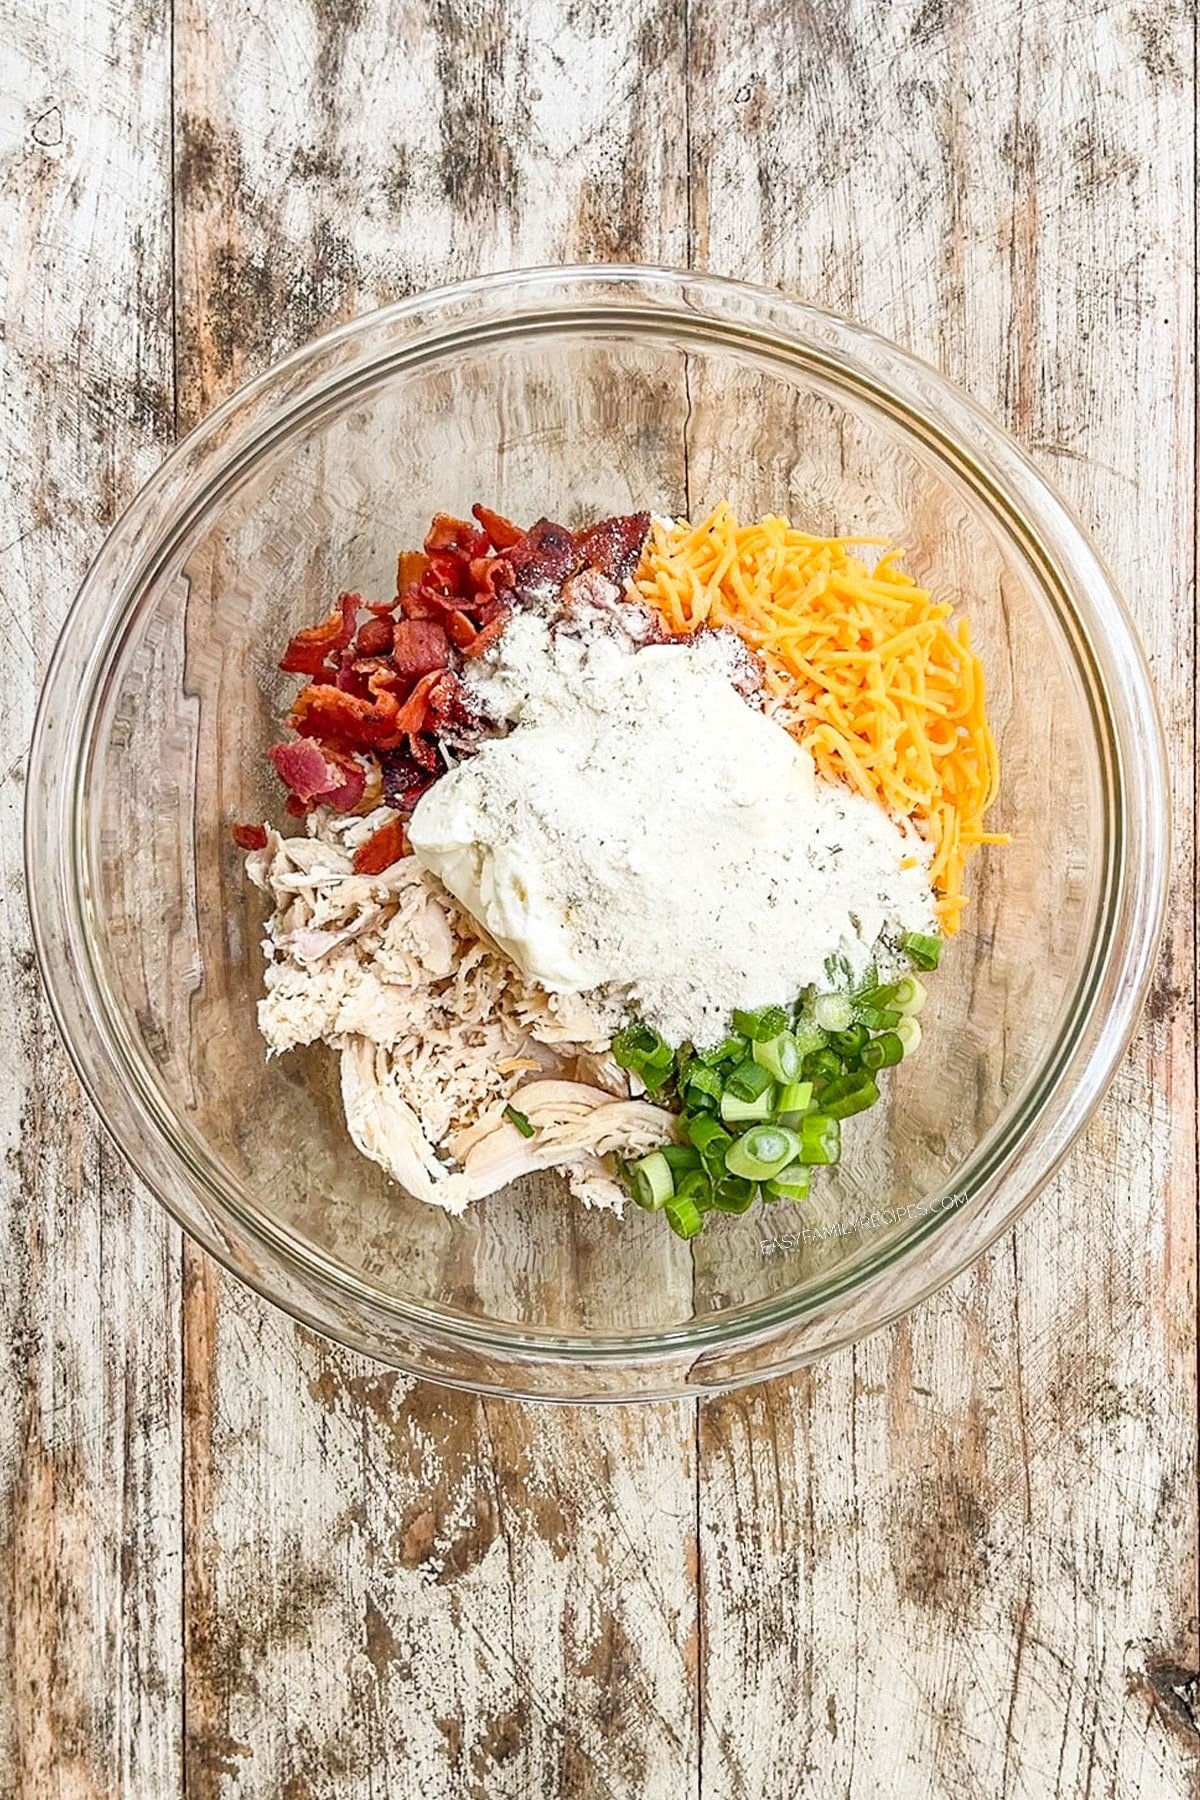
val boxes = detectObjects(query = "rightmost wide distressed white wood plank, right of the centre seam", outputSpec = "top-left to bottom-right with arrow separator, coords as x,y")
689,0 -> 1200,1800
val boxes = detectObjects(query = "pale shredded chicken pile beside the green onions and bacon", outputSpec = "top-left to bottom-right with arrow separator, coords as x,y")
246,808 -> 665,1213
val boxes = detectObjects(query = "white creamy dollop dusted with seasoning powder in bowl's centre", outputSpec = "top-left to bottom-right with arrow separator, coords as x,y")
408,614 -> 936,1046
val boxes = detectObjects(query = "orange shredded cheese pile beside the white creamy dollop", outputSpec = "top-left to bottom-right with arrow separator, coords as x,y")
633,506 -> 1006,932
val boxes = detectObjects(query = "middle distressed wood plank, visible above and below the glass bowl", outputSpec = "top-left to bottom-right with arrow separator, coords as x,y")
176,0 -> 696,1800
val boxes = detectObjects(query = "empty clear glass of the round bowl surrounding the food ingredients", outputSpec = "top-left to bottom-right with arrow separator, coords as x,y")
27,268 -> 1168,1399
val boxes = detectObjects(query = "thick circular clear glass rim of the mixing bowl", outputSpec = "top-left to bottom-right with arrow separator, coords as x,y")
25,265 -> 1169,1399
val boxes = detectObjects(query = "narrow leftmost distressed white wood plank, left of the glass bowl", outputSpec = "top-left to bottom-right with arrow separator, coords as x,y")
0,0 -> 182,1800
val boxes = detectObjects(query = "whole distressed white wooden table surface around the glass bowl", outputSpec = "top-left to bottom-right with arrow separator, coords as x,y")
0,0 -> 1200,1800
